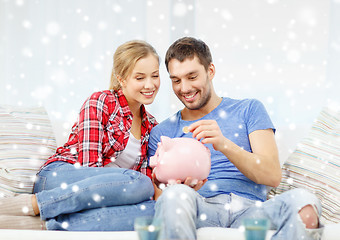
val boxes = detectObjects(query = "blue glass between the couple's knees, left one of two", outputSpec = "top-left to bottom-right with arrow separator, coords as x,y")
134,216 -> 162,240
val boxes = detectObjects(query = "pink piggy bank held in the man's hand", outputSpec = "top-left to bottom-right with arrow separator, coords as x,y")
150,136 -> 211,184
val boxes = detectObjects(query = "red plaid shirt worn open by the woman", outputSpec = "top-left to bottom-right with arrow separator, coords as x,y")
44,90 -> 157,177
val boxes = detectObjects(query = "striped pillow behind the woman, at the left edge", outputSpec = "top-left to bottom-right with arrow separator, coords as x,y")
0,105 -> 56,197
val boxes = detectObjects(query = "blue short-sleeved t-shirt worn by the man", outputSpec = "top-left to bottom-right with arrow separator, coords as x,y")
148,98 -> 275,201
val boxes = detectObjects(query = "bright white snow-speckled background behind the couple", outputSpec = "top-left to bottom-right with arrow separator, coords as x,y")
0,0 -> 340,161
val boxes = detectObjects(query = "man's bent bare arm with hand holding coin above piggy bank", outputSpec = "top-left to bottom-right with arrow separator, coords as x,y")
189,120 -> 281,187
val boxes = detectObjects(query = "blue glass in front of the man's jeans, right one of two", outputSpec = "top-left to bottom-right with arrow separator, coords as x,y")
243,218 -> 269,240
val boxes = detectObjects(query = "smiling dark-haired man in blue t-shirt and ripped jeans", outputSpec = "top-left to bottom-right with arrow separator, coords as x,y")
148,37 -> 321,239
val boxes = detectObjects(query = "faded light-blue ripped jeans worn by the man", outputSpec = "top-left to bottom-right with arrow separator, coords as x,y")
155,184 -> 322,240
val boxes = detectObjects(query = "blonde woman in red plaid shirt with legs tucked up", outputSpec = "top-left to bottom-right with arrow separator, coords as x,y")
0,41 -> 160,230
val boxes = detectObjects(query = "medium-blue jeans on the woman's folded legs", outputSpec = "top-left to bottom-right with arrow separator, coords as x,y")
33,162 -> 154,231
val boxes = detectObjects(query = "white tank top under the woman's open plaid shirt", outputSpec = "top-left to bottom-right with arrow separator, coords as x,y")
105,133 -> 141,168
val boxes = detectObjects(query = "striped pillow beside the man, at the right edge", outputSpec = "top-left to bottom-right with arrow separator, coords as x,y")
270,108 -> 340,224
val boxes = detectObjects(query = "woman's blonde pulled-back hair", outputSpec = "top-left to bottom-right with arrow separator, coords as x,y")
109,40 -> 159,90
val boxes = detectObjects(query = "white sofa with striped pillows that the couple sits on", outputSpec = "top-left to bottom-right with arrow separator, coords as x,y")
0,105 -> 340,240
